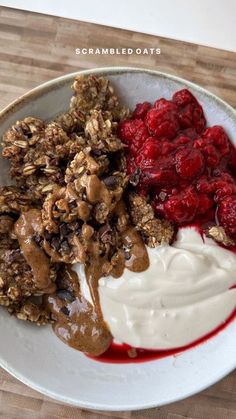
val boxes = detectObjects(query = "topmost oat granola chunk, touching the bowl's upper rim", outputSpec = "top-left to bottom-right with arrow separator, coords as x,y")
70,75 -> 128,121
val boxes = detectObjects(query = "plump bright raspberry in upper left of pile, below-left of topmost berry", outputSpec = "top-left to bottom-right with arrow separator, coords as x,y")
145,108 -> 179,139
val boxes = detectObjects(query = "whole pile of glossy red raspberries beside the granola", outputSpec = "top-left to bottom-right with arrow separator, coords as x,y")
118,89 -> 236,238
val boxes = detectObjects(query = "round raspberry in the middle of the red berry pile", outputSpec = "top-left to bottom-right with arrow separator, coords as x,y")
175,147 -> 204,180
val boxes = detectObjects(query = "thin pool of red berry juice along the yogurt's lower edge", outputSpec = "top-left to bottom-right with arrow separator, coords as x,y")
88,308 -> 236,364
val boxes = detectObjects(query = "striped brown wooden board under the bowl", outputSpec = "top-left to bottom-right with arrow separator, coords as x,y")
0,7 -> 236,419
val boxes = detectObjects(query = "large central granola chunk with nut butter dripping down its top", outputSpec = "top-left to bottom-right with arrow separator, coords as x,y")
42,143 -> 128,263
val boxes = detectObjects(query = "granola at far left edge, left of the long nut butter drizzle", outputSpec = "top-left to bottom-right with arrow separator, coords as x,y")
0,186 -> 56,325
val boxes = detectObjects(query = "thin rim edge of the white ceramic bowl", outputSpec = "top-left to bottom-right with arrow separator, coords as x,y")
0,66 -> 236,411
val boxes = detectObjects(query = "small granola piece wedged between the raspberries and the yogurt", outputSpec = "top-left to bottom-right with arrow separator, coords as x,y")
128,192 -> 174,247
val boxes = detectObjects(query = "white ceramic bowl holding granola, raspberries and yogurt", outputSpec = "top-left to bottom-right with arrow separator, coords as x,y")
0,68 -> 236,410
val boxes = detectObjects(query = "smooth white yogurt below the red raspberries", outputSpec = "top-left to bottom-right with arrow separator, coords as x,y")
74,228 -> 236,349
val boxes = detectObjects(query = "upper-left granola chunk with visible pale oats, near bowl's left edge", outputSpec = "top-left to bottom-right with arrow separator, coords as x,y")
3,118 -> 85,200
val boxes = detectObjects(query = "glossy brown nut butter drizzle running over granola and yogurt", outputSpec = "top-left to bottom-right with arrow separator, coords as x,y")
15,202 -> 149,356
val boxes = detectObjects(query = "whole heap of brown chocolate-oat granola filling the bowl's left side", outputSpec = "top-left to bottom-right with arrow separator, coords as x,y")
0,76 -> 173,325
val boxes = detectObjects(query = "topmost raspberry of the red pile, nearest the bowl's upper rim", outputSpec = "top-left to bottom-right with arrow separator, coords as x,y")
172,89 -> 206,133
